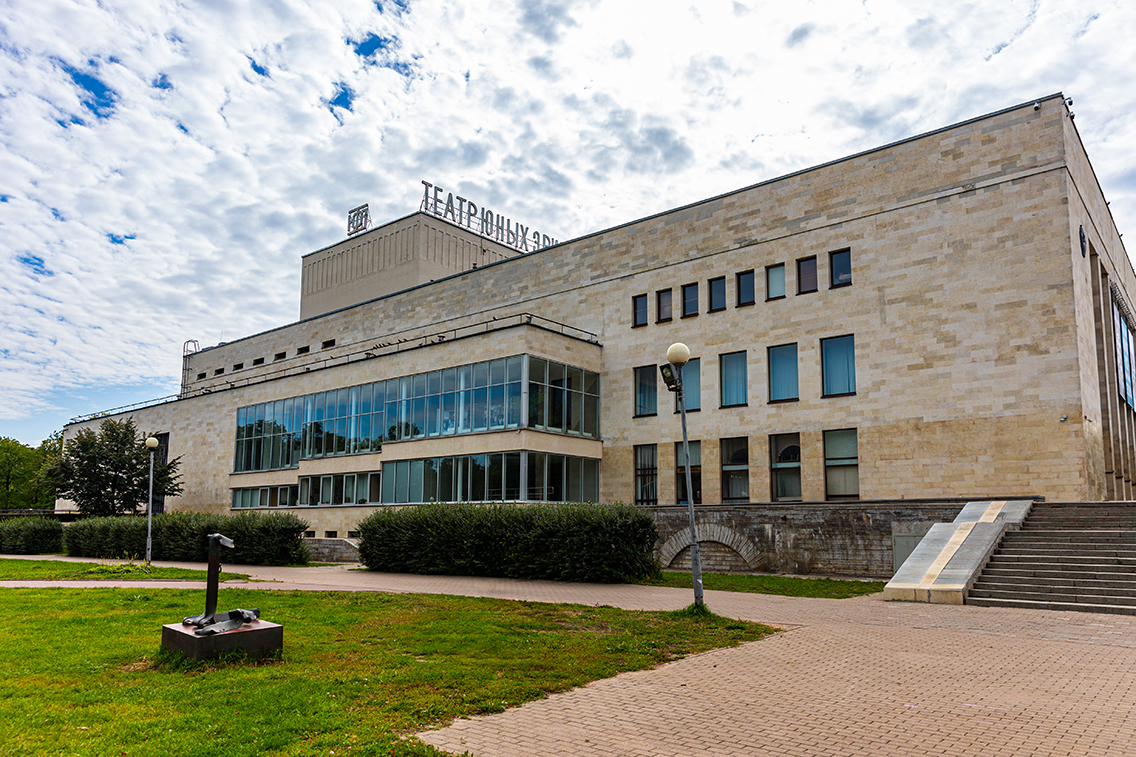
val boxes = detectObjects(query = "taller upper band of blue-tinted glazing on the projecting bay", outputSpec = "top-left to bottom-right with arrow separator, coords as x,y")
233,355 -> 600,473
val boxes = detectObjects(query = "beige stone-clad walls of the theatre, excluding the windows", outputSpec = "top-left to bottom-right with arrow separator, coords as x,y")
59,95 -> 1136,535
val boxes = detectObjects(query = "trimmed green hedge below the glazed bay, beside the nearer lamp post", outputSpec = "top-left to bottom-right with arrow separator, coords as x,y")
358,504 -> 659,583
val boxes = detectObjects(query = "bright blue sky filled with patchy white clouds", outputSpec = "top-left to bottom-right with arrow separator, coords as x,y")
0,0 -> 1136,443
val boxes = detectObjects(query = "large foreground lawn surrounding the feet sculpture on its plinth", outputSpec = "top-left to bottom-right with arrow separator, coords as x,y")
0,588 -> 772,757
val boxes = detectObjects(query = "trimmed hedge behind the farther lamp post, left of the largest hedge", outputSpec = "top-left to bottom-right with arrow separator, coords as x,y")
64,513 -> 308,565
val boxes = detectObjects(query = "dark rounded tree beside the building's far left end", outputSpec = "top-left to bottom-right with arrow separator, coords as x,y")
45,418 -> 183,516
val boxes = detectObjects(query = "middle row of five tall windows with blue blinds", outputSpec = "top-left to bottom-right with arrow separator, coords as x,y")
634,334 -> 855,417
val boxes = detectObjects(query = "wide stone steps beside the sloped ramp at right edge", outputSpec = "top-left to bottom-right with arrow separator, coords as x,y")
966,502 -> 1136,615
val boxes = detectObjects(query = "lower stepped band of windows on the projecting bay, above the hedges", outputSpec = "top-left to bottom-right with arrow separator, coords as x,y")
233,450 -> 600,508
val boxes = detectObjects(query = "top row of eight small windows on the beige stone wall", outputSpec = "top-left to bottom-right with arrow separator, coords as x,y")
632,250 -> 852,328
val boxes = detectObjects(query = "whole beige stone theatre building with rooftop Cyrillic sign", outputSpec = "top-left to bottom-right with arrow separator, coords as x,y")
59,95 -> 1136,536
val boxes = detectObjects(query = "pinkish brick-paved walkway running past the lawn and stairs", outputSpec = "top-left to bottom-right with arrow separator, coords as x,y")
0,552 -> 1136,757
